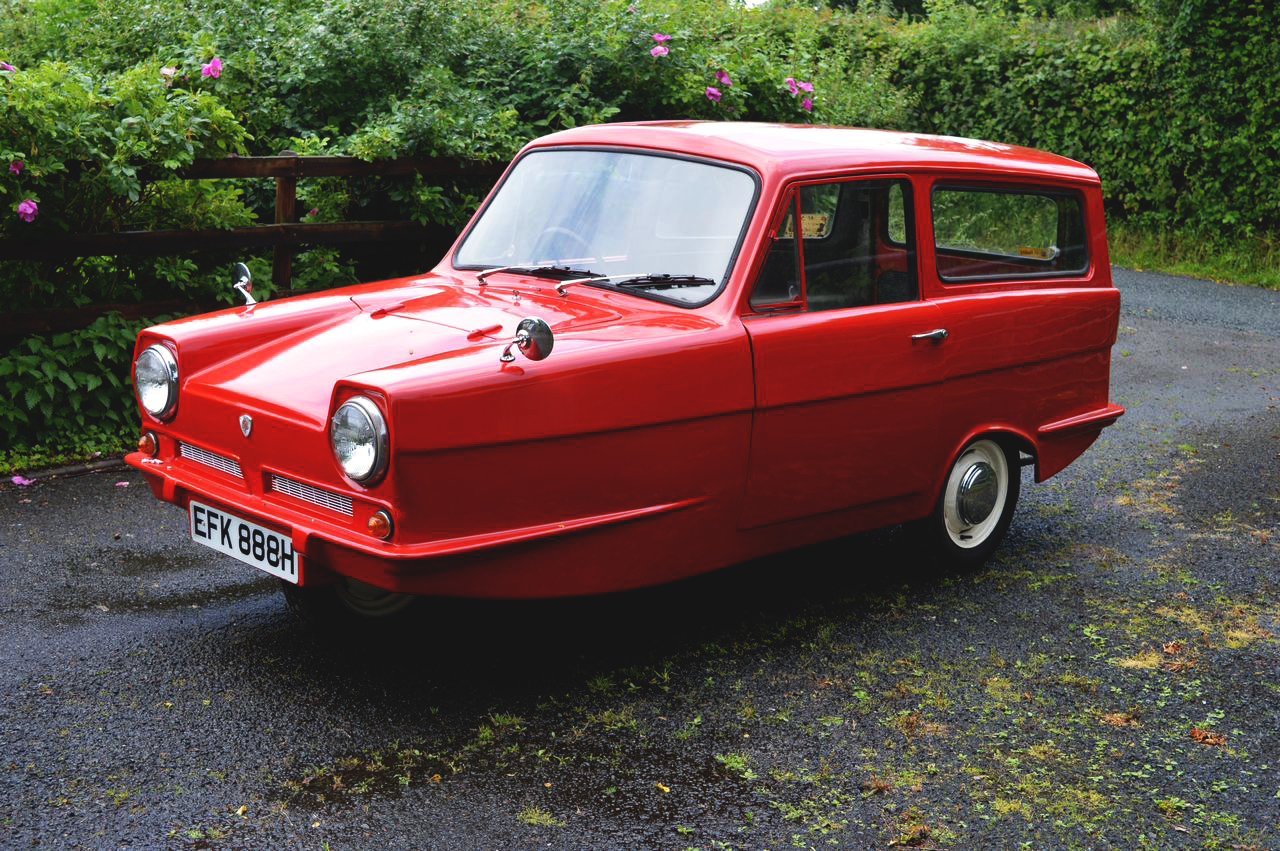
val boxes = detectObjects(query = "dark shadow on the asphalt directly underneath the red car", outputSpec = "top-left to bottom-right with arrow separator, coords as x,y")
244,527 -> 972,704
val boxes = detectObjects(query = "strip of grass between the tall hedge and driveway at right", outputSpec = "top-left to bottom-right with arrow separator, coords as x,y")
1107,221 -> 1280,289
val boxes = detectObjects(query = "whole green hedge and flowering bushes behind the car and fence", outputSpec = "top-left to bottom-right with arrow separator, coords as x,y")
0,0 -> 1280,460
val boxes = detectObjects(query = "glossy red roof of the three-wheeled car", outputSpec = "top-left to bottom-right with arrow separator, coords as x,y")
530,122 -> 1098,183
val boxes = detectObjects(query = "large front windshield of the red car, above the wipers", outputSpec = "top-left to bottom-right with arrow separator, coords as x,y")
454,148 -> 755,305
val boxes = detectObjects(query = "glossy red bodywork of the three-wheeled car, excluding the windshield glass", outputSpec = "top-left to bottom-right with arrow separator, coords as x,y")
127,123 -> 1123,611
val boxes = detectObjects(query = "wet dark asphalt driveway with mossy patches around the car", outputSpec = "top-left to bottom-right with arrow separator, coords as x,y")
0,270 -> 1280,850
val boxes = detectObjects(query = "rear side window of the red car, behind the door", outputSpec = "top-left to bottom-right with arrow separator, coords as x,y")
932,186 -> 1089,280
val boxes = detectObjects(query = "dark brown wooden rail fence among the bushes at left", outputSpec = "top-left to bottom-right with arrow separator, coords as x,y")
0,151 -> 504,337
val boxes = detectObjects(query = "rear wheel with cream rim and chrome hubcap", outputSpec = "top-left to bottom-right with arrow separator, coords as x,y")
928,438 -> 1021,568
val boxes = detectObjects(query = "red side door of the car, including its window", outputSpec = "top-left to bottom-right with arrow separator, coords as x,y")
741,175 -> 947,529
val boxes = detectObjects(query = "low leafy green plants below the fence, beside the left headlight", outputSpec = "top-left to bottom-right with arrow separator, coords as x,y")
0,315 -> 160,448
